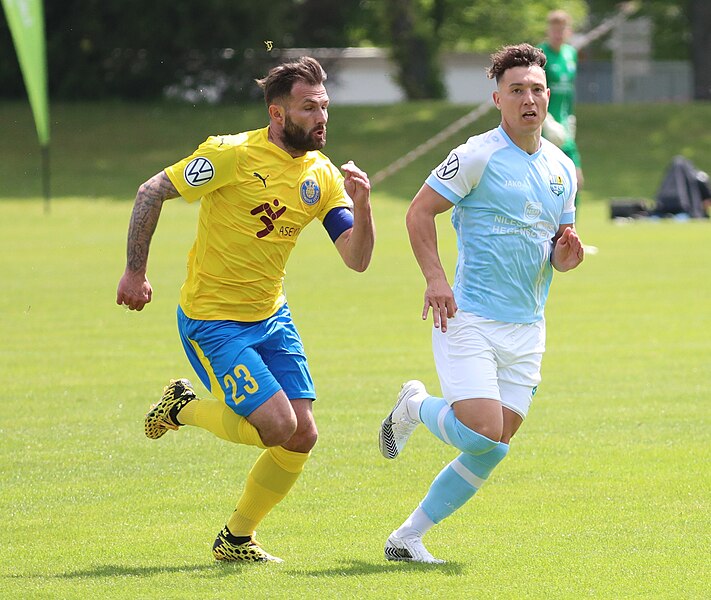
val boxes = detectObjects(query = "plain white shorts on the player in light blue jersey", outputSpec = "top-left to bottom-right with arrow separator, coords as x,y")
432,310 -> 546,418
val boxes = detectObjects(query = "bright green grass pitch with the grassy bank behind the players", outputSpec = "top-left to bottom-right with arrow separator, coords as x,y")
0,104 -> 711,599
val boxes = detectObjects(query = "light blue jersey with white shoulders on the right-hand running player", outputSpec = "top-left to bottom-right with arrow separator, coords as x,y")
426,126 -> 577,323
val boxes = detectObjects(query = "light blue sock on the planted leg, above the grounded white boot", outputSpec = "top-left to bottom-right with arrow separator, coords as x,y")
420,442 -> 509,523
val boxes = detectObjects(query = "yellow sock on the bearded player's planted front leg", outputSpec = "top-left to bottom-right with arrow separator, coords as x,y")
227,446 -> 311,535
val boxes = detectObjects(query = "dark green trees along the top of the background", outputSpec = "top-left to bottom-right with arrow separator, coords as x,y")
0,0 -> 711,101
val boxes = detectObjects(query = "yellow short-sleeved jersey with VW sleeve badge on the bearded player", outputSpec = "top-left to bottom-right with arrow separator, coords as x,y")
165,127 -> 351,321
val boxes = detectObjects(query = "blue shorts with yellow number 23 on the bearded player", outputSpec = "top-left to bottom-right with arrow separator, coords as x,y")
178,304 -> 316,417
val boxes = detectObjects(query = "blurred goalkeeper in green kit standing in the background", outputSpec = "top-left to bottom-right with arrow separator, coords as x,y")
541,10 -> 583,197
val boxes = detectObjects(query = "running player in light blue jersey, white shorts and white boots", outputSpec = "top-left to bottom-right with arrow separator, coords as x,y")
380,44 -> 584,563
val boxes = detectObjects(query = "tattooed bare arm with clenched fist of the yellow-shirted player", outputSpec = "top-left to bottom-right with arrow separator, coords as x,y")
116,171 -> 179,310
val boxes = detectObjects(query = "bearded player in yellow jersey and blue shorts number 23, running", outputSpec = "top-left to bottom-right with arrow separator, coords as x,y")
116,57 -> 375,562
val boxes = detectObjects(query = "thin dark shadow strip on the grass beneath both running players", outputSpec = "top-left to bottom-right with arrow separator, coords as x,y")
22,560 -> 463,579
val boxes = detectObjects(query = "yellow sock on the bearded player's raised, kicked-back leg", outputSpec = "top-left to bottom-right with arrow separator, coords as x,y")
178,400 -> 266,448
